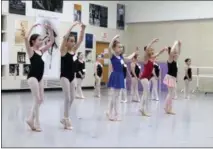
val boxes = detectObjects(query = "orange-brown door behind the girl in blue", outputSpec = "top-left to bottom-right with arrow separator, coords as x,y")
96,42 -> 109,84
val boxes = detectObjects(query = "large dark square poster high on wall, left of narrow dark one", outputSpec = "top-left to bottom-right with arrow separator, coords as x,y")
89,4 -> 108,28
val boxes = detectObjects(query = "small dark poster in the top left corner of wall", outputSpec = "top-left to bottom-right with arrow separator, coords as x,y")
9,0 -> 26,15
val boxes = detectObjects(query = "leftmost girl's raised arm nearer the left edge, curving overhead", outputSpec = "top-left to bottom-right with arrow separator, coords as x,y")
22,24 -> 41,57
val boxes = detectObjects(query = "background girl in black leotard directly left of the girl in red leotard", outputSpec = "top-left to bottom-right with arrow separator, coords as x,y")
131,50 -> 141,102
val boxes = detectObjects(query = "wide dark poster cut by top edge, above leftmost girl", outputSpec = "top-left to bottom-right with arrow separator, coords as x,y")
32,0 -> 63,13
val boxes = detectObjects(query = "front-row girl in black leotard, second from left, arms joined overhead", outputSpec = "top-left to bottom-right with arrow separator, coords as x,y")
60,22 -> 86,129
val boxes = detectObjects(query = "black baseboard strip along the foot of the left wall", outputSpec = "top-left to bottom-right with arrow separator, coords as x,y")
1,86 -> 94,93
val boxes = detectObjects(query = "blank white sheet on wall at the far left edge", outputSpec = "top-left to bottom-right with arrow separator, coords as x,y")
1,42 -> 9,65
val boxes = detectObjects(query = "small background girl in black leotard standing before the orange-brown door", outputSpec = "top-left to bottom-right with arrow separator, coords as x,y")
95,55 -> 103,98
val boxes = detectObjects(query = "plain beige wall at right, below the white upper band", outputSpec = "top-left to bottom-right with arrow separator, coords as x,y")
127,19 -> 213,92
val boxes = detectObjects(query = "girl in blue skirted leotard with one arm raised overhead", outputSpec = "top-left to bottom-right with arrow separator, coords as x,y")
106,35 -> 136,121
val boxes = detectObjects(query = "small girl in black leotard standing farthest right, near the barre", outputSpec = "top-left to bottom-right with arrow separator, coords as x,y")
184,58 -> 192,99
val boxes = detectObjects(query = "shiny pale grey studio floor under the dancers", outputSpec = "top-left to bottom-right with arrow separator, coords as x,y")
2,90 -> 213,147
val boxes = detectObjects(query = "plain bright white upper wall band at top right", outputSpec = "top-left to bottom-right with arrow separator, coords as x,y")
126,1 -> 213,23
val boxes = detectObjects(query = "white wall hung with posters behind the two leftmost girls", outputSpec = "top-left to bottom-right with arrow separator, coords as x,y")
2,1 -> 127,89
